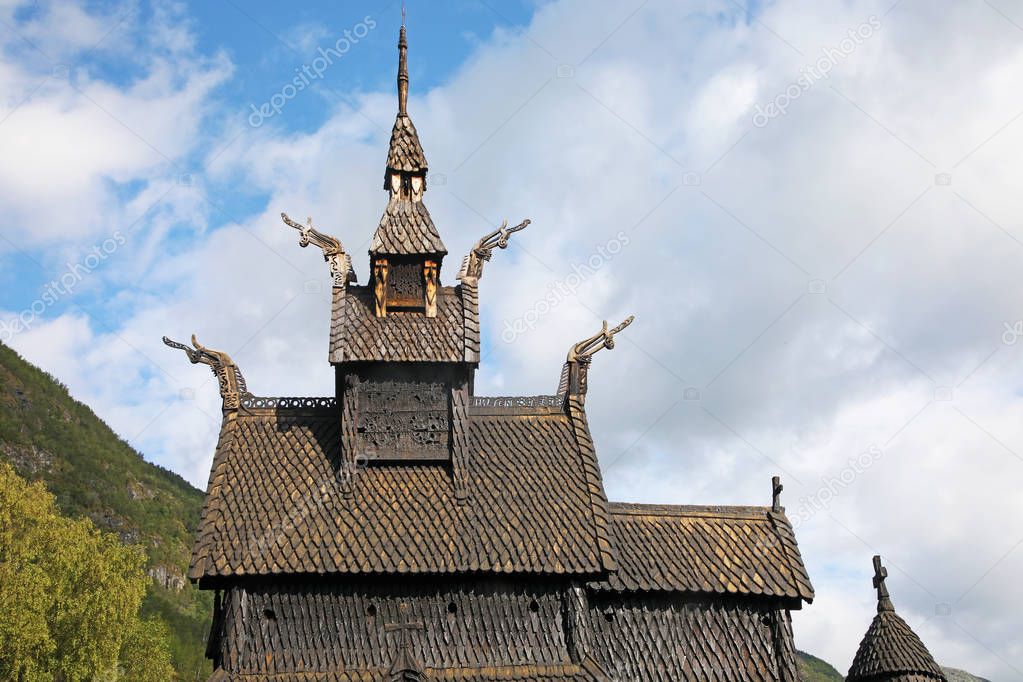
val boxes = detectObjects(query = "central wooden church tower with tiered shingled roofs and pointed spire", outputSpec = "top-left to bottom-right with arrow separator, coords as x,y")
315,26 -> 499,482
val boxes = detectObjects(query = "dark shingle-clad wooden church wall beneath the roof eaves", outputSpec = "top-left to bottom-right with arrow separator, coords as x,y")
209,578 -> 796,681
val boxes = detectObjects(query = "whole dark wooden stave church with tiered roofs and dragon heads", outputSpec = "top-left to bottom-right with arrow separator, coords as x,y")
171,17 -> 818,682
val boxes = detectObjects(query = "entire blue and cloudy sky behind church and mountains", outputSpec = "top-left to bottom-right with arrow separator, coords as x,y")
0,0 -> 1023,680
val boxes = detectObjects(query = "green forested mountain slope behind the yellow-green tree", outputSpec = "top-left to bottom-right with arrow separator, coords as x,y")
0,344 -> 212,680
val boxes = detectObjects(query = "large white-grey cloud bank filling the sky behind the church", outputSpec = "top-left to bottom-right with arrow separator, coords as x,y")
0,0 -> 1023,679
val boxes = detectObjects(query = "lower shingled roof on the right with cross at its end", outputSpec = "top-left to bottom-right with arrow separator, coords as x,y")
591,502 -> 813,601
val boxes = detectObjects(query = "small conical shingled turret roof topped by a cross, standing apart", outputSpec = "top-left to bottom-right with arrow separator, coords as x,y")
846,556 -> 946,682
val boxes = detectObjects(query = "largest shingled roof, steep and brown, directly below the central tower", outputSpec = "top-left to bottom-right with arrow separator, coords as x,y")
189,409 -> 609,580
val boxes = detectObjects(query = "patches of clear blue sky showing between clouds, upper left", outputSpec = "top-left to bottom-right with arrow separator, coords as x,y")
0,1 -> 533,325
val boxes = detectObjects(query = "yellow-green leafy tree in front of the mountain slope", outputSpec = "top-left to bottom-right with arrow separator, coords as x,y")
0,463 -> 173,682
